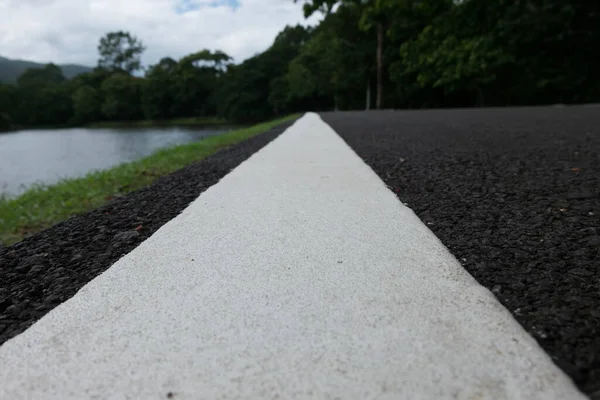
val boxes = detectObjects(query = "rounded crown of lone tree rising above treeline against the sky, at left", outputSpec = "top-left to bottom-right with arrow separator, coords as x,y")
98,31 -> 146,74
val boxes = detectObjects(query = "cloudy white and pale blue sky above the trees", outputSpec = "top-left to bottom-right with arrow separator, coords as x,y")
0,0 -> 317,66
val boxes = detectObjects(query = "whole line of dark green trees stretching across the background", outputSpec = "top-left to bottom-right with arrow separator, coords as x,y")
0,0 -> 600,130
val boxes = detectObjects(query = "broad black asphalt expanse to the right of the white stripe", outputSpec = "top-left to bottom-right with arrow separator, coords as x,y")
321,106 -> 600,399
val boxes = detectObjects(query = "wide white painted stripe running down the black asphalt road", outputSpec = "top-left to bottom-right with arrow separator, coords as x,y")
0,114 -> 584,400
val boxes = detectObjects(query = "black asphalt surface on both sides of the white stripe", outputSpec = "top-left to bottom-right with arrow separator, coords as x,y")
0,106 -> 600,399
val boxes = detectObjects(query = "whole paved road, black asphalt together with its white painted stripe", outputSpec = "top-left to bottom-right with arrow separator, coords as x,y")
0,107 -> 600,399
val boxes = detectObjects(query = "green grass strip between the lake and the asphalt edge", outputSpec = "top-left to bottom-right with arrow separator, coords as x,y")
0,115 -> 298,245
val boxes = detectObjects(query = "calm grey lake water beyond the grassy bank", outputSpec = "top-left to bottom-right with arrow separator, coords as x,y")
0,127 -> 229,195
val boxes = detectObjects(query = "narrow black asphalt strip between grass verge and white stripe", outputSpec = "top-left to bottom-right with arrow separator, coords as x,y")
0,121 -> 293,345
